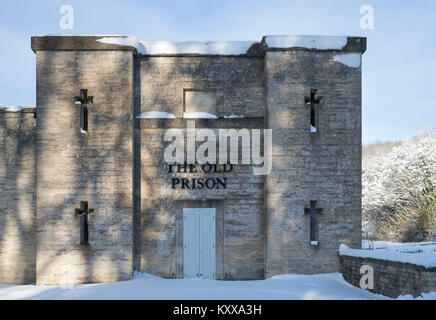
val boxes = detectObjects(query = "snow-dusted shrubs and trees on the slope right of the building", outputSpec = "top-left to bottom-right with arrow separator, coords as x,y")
362,130 -> 436,241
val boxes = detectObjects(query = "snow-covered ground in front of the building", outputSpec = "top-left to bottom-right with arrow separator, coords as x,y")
0,273 -> 387,300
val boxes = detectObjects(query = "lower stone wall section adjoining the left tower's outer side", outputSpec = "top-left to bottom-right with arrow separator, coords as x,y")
0,108 -> 36,284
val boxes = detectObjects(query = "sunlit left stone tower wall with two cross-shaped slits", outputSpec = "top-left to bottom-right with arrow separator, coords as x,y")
33,47 -> 133,285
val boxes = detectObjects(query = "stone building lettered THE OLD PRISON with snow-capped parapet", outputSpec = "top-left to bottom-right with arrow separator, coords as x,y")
0,36 -> 366,285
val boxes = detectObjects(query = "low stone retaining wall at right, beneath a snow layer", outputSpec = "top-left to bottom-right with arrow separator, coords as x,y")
341,255 -> 436,298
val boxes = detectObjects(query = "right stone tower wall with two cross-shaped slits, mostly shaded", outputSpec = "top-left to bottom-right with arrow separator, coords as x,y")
265,49 -> 361,277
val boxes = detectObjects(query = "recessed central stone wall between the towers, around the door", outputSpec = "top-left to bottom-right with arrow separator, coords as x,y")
137,57 -> 264,280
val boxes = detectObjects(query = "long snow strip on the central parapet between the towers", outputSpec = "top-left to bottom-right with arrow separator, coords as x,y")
138,41 -> 256,55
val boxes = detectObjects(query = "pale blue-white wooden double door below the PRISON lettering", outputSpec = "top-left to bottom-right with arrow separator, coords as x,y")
183,208 -> 216,279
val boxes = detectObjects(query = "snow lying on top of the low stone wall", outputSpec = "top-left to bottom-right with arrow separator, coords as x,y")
339,244 -> 436,268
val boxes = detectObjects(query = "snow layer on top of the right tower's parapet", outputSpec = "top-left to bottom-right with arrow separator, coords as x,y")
265,35 -> 347,50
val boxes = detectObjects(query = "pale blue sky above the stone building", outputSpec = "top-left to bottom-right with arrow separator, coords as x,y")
0,0 -> 436,144
